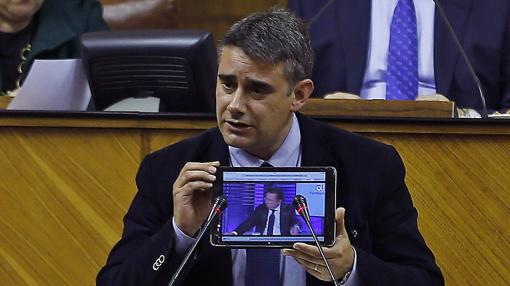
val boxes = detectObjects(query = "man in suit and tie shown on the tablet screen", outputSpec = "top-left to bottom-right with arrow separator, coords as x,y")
232,187 -> 300,235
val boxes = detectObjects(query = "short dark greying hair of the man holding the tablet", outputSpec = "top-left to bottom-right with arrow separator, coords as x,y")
220,7 -> 313,86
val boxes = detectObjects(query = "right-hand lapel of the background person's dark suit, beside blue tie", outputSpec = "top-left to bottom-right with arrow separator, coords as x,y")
434,0 -> 472,96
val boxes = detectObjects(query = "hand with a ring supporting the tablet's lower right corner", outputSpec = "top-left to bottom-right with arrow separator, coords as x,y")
282,208 -> 354,281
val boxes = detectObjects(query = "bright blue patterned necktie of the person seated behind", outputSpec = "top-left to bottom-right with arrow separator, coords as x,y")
386,0 -> 419,100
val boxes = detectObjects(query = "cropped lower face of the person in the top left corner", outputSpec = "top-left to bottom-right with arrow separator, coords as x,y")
0,0 -> 43,23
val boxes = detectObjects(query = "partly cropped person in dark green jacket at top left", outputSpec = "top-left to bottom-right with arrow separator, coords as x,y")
0,0 -> 108,96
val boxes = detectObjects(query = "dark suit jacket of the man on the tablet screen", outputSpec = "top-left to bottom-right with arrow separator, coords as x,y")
234,204 -> 298,235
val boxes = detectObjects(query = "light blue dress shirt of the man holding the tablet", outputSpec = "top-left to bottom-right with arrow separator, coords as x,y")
172,114 -> 359,286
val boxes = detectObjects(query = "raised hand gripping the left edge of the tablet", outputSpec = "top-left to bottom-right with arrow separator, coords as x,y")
173,161 -> 220,236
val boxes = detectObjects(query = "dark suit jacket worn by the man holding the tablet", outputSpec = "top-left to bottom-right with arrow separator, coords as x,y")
97,114 -> 444,286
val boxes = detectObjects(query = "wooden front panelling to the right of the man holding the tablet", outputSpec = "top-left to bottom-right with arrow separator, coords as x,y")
371,134 -> 510,285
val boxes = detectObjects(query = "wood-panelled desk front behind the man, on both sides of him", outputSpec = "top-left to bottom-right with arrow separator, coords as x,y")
0,112 -> 510,286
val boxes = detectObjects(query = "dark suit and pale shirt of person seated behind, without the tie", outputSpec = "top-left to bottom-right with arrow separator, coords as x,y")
288,0 -> 510,113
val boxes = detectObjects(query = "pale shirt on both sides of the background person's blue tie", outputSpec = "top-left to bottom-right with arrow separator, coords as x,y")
360,0 -> 436,99
